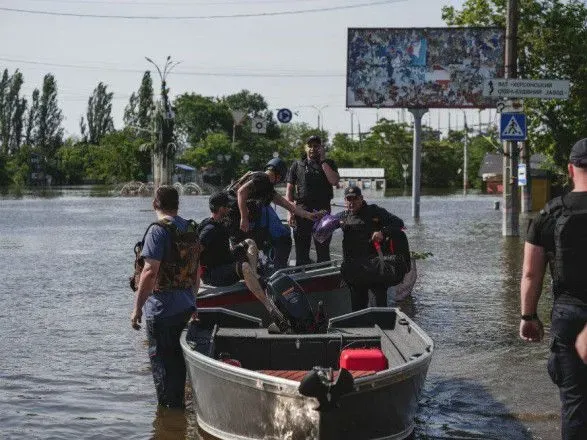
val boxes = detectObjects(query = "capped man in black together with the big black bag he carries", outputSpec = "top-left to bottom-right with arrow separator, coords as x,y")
336,185 -> 411,311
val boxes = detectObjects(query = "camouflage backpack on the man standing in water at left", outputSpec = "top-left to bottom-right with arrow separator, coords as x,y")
129,219 -> 201,292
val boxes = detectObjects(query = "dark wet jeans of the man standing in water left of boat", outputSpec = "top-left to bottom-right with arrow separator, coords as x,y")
146,310 -> 192,408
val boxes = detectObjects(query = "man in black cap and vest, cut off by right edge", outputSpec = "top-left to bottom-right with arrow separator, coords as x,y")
520,138 -> 587,440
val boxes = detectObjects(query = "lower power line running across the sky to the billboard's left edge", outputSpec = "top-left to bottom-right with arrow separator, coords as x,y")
0,57 -> 346,78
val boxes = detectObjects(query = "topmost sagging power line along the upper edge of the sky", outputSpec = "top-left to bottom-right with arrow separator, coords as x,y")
0,0 -> 407,20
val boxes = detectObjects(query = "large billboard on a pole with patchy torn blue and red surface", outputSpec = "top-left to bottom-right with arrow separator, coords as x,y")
346,28 -> 505,108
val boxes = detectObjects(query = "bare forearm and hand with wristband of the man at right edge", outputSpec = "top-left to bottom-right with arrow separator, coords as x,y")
520,242 -> 546,342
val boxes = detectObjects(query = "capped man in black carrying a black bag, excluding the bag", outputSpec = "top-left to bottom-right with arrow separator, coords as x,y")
337,185 -> 405,311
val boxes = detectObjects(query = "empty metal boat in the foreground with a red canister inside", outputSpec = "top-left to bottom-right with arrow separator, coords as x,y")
181,308 -> 433,440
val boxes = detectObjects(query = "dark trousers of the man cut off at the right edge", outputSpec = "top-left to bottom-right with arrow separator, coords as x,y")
548,302 -> 587,440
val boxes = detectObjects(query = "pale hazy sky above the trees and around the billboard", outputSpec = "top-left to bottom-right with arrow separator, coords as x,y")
0,0 -> 474,141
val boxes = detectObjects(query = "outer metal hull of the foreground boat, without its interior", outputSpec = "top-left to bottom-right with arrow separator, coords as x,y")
181,312 -> 432,440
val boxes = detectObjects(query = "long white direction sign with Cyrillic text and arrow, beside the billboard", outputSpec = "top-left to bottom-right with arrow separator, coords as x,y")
483,78 -> 570,99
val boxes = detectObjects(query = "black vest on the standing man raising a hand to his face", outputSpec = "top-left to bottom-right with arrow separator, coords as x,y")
296,158 -> 334,205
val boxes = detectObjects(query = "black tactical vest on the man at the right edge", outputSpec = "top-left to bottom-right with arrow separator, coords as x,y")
545,197 -> 587,302
